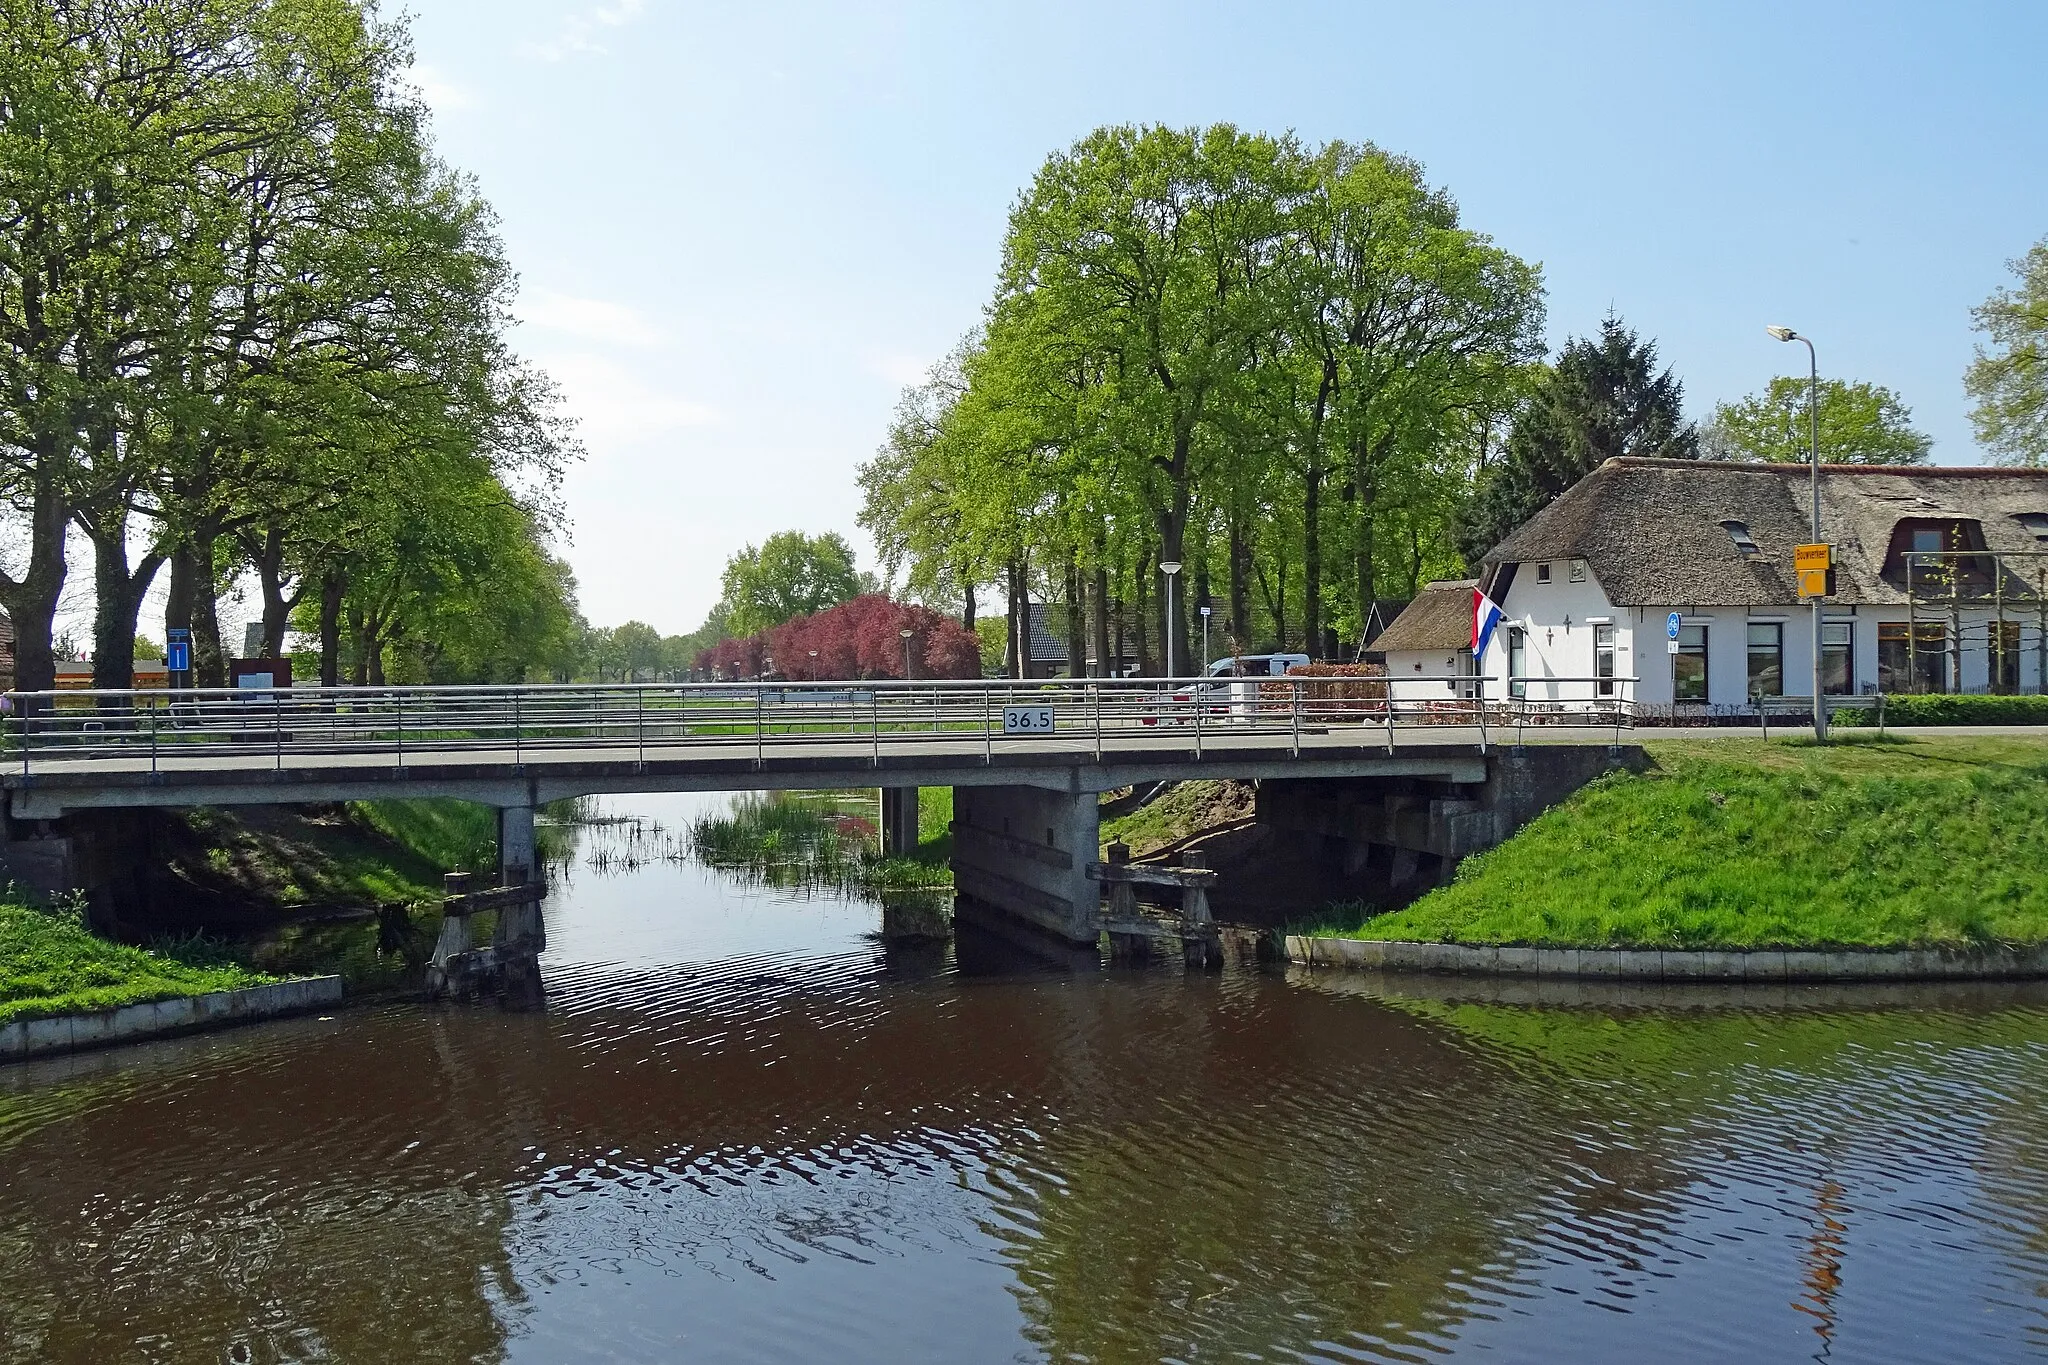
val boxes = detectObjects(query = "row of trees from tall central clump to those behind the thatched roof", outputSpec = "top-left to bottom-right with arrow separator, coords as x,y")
860,125 -> 1957,673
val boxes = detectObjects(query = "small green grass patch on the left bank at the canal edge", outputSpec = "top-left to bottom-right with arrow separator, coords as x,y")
0,902 -> 276,1023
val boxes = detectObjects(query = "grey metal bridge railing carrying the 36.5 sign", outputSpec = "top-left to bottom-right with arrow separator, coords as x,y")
4,675 -> 1634,774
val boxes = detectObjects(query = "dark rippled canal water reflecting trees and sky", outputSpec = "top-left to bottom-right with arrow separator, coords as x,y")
0,798 -> 2048,1365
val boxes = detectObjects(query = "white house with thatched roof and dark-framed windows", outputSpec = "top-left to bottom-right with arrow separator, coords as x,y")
1449,458 -> 2048,710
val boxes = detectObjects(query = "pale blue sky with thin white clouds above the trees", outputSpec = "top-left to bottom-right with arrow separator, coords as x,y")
395,0 -> 2048,632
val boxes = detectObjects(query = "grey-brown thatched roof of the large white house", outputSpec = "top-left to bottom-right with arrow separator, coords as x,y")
1485,458 -> 2048,606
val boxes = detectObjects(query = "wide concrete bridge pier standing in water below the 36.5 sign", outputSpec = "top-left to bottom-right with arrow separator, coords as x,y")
952,786 -> 1102,948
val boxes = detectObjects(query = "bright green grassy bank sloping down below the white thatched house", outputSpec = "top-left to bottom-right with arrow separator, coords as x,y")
1317,735 -> 2048,948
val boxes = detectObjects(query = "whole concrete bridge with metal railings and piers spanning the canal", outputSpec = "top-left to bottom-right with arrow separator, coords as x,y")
0,677 -> 1630,943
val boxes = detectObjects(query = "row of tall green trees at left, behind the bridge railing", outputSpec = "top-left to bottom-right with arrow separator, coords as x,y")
0,0 -> 578,688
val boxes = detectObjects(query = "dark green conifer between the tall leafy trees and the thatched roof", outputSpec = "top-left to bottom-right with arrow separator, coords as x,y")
1458,317 -> 1700,565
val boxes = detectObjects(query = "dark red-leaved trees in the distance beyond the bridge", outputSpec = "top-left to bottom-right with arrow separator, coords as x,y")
696,593 -> 981,681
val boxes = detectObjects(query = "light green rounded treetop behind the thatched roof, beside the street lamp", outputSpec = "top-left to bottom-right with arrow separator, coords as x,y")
1700,375 -> 1933,465
